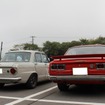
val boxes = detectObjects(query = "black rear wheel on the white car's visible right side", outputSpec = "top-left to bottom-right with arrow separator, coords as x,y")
26,74 -> 37,89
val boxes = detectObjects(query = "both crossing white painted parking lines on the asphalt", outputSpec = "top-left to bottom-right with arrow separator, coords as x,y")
0,86 -> 105,105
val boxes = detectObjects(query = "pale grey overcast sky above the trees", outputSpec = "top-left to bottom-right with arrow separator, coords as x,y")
0,0 -> 105,52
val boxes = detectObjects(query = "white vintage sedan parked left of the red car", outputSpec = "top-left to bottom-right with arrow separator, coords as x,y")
0,50 -> 49,88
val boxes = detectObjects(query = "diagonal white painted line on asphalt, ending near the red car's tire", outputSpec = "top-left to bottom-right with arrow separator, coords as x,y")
5,86 -> 57,105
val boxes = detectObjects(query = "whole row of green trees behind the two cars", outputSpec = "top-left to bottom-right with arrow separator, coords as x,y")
14,36 -> 105,57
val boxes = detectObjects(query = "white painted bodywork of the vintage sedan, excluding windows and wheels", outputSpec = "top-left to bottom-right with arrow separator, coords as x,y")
0,50 -> 49,83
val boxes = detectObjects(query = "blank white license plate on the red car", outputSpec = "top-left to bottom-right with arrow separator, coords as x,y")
73,67 -> 88,75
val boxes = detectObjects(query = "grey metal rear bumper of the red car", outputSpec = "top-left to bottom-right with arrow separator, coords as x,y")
49,75 -> 105,82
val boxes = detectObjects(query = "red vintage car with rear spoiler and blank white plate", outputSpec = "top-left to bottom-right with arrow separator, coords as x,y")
49,45 -> 105,91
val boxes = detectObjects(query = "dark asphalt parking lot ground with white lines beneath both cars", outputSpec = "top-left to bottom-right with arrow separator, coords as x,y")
0,82 -> 105,105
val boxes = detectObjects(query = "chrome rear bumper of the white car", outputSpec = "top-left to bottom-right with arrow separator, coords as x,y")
0,77 -> 21,83
